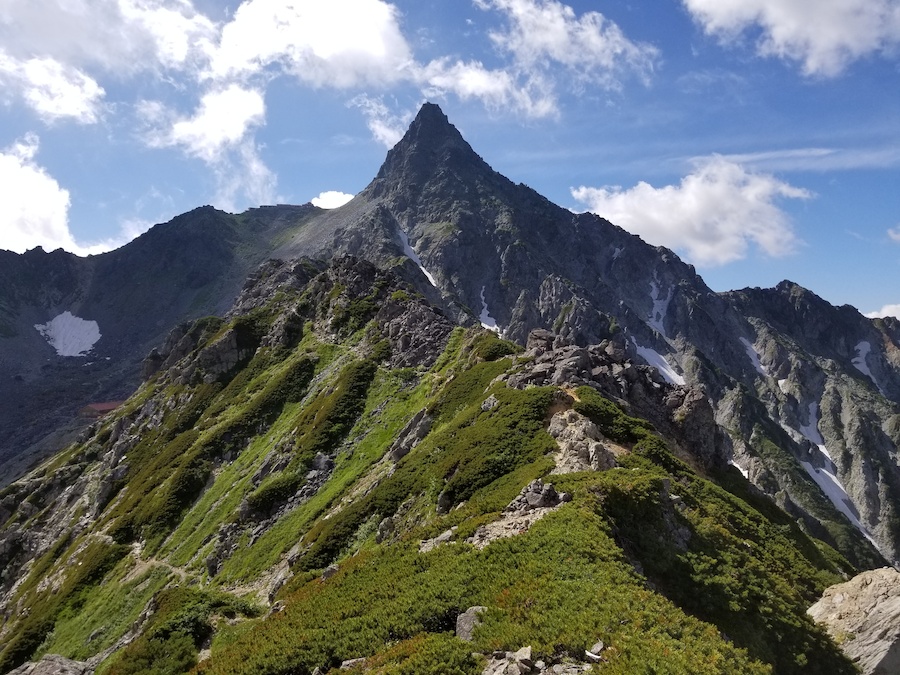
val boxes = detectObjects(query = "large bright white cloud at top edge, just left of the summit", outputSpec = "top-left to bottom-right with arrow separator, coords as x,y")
208,0 -> 412,88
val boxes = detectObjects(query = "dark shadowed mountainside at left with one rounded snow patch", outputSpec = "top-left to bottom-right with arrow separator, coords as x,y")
0,205 -> 319,485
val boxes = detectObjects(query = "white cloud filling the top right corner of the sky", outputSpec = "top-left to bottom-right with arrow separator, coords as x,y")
683,0 -> 900,77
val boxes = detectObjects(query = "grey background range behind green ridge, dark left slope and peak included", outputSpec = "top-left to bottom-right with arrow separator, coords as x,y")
0,104 -> 900,565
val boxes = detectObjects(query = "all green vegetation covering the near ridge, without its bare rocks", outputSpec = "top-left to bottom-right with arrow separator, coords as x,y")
0,290 -> 854,675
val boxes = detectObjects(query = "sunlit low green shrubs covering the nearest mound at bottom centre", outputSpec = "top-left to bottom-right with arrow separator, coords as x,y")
199,506 -> 769,674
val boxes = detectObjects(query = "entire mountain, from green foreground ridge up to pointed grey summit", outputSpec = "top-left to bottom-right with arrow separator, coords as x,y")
0,104 -> 900,675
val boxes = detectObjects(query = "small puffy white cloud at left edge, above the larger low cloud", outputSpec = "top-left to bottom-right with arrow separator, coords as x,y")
0,50 -> 105,124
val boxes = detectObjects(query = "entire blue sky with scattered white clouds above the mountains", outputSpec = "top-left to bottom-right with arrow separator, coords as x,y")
0,0 -> 900,315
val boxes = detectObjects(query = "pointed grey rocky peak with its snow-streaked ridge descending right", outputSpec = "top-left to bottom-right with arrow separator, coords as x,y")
270,104 -> 900,562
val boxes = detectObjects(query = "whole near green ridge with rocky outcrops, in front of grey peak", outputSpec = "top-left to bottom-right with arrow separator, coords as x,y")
0,258 -> 872,675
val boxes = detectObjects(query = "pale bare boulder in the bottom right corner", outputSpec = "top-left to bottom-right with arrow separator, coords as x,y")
808,567 -> 900,675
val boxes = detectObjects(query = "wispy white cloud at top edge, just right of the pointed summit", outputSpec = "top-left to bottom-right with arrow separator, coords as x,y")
474,0 -> 658,87
